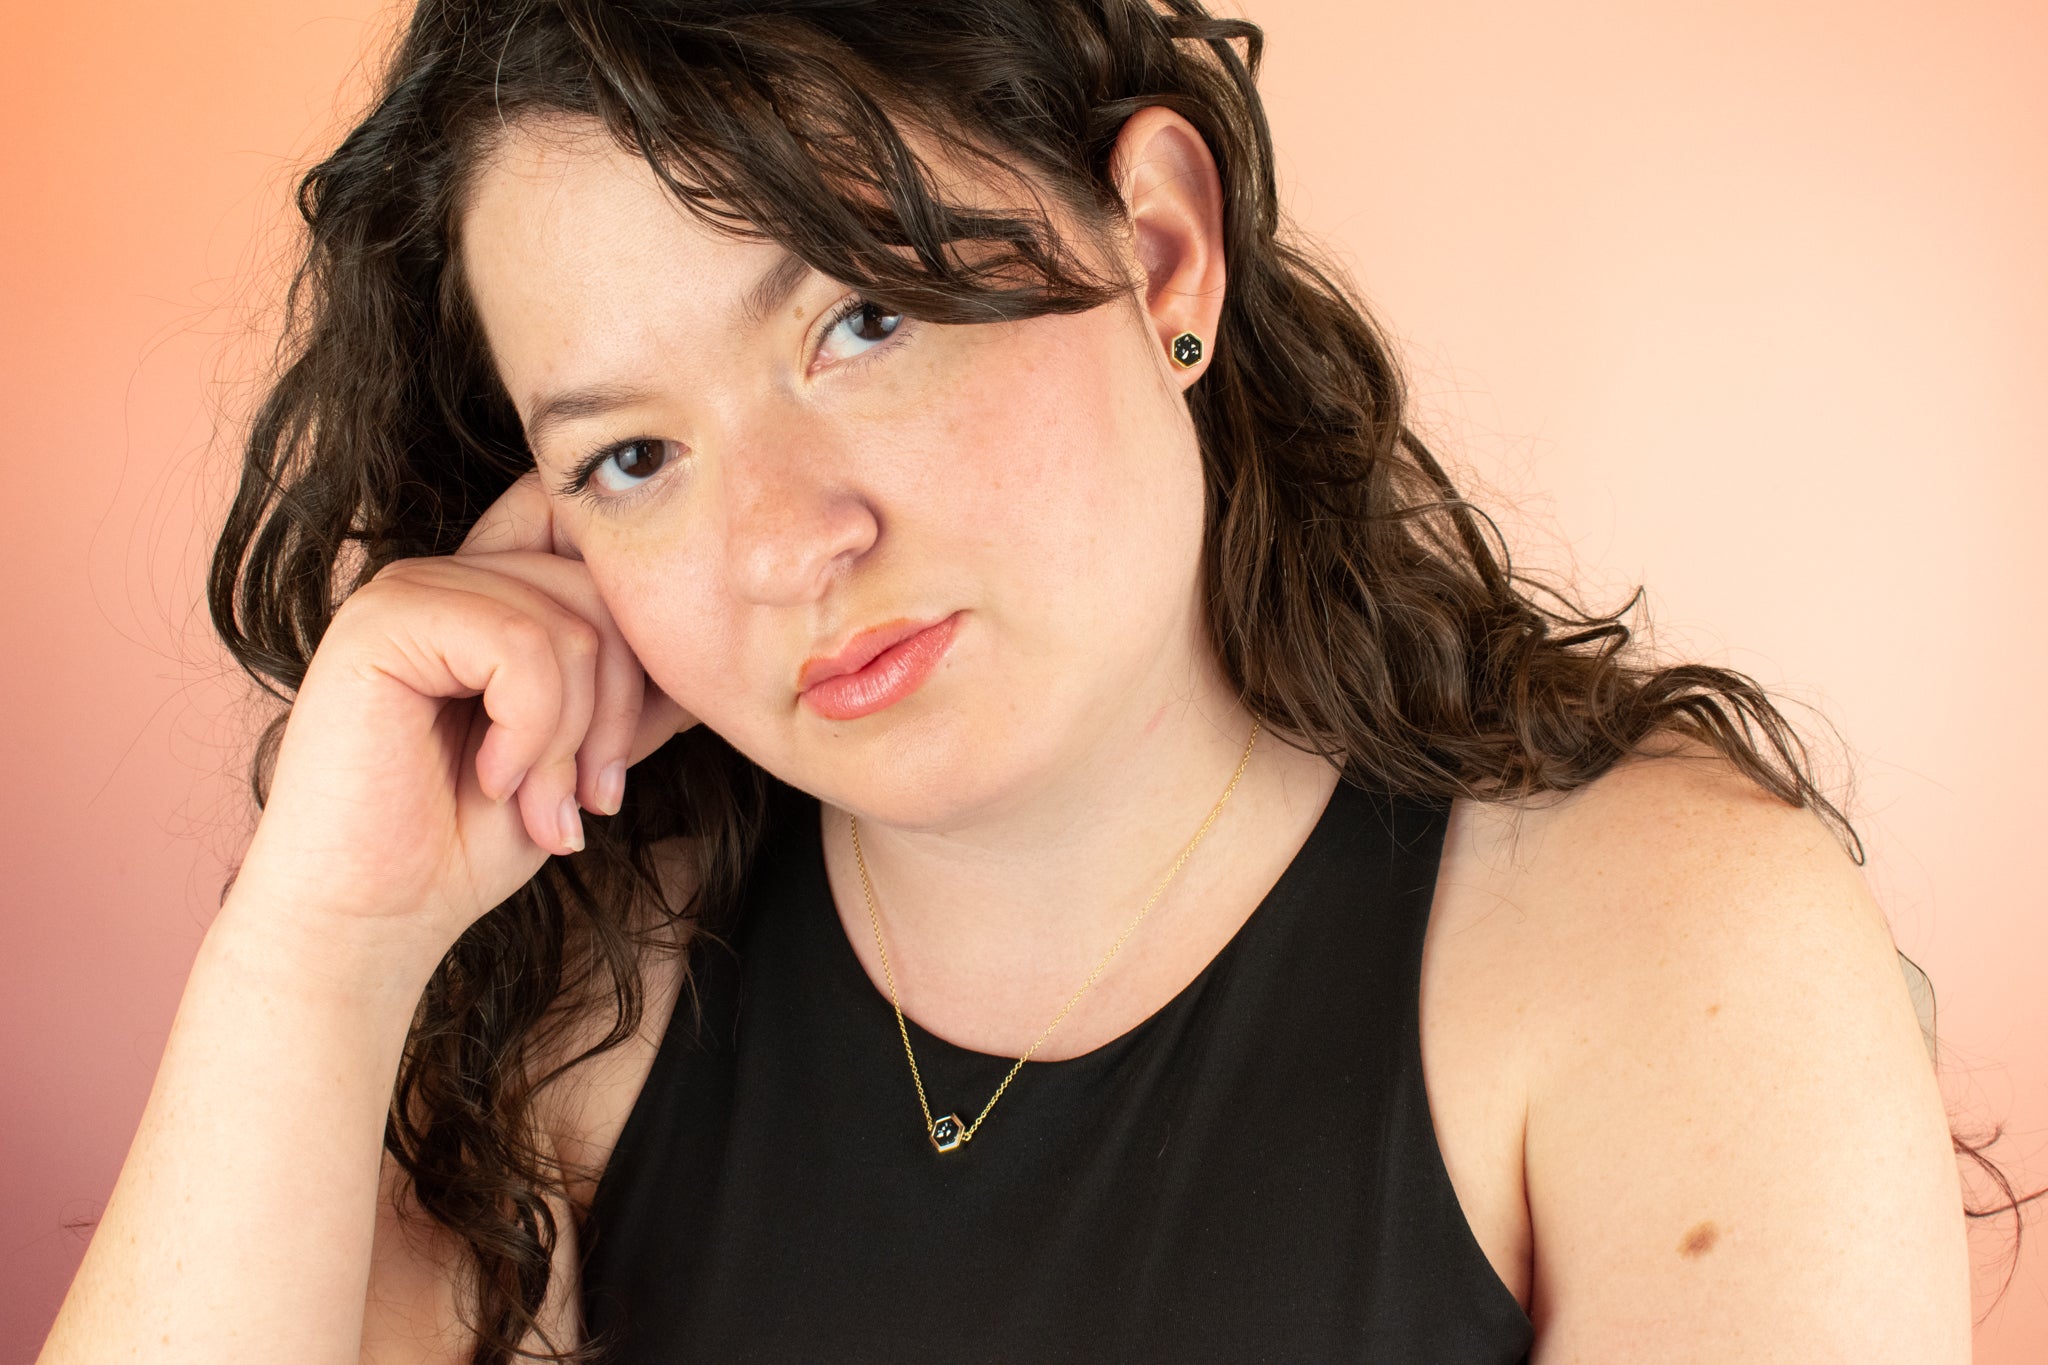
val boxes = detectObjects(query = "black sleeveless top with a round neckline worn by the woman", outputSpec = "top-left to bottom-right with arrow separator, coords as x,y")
582,782 -> 1534,1365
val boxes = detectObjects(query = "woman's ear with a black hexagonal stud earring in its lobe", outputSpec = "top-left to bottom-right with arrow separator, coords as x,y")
1110,104 -> 1225,389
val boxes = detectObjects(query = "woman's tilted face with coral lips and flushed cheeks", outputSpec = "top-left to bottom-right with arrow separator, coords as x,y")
461,123 -> 1214,827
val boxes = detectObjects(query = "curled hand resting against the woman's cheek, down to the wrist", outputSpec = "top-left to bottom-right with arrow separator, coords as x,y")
236,475 -> 696,950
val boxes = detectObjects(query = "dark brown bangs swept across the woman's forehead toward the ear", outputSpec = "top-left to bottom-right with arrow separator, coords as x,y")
449,0 -> 1135,323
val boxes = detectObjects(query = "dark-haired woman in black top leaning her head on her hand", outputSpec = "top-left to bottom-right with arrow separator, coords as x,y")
43,0 -> 1968,1361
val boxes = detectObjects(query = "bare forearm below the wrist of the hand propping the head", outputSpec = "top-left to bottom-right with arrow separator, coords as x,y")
39,896 -> 438,1365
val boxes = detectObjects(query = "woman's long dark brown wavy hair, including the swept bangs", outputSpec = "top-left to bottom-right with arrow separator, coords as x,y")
209,0 -> 2015,1363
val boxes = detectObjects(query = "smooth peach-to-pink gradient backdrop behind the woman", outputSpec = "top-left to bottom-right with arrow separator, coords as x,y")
0,0 -> 2048,1365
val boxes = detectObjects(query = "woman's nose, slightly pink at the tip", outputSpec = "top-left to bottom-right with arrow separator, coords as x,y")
721,428 -> 881,606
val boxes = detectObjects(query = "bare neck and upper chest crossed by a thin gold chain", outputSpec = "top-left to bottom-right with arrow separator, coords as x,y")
821,692 -> 1335,1060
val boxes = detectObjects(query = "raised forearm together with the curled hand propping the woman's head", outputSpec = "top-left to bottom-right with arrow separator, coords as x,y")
41,475 -> 694,1365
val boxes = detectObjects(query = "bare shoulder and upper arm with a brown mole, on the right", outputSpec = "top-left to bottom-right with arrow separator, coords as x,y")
1425,745 -> 1970,1361
